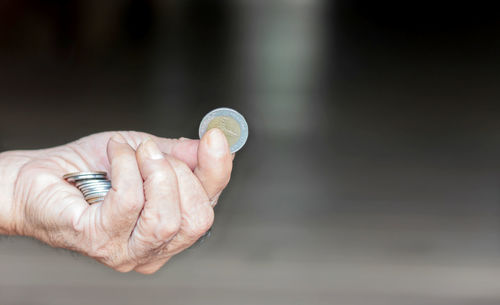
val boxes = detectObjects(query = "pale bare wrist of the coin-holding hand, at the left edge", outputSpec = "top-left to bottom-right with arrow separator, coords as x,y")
0,151 -> 31,235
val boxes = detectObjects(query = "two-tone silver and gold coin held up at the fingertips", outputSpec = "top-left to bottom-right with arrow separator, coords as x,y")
199,108 -> 248,153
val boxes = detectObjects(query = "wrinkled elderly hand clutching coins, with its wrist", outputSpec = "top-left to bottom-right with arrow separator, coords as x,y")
0,129 -> 233,273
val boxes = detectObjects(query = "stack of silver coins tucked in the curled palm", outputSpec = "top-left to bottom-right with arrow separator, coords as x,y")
63,172 -> 111,204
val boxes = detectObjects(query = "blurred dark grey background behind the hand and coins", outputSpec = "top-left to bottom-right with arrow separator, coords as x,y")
0,0 -> 500,305
